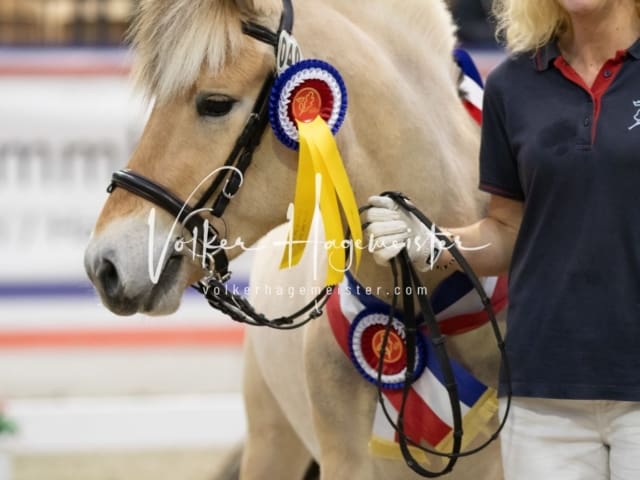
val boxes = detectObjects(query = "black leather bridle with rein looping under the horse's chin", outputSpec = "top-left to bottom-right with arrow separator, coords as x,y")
107,0 -> 332,330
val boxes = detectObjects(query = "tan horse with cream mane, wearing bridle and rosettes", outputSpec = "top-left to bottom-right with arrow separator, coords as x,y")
85,0 -> 502,480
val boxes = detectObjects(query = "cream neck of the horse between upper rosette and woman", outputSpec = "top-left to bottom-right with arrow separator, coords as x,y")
288,0 -> 483,292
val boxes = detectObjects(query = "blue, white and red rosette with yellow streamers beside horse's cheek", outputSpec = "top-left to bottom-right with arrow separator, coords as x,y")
270,60 -> 362,285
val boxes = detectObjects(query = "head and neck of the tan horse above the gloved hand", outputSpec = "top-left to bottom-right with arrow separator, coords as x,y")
85,0 -> 482,314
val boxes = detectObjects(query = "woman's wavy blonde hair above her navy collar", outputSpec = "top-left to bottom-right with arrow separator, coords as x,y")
493,0 -> 640,53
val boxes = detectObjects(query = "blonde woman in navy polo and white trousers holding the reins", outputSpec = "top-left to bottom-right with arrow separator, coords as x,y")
367,0 -> 640,480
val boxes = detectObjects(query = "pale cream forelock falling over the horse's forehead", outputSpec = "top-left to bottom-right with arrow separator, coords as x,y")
129,0 -> 281,101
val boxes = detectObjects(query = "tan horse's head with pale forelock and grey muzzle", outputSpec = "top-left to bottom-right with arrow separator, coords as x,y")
85,0 -> 295,315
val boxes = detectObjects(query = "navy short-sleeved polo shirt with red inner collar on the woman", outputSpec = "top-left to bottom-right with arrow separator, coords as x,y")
480,40 -> 640,401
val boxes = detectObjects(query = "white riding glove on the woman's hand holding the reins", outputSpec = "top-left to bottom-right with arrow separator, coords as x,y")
364,196 -> 445,272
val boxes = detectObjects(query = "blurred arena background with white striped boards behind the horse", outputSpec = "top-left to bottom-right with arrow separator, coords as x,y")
0,0 -> 502,480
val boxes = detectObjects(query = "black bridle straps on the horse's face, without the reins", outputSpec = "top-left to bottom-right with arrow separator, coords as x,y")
107,0 -> 293,283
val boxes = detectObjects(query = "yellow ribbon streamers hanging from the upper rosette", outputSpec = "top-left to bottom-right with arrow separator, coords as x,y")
280,116 -> 362,285
